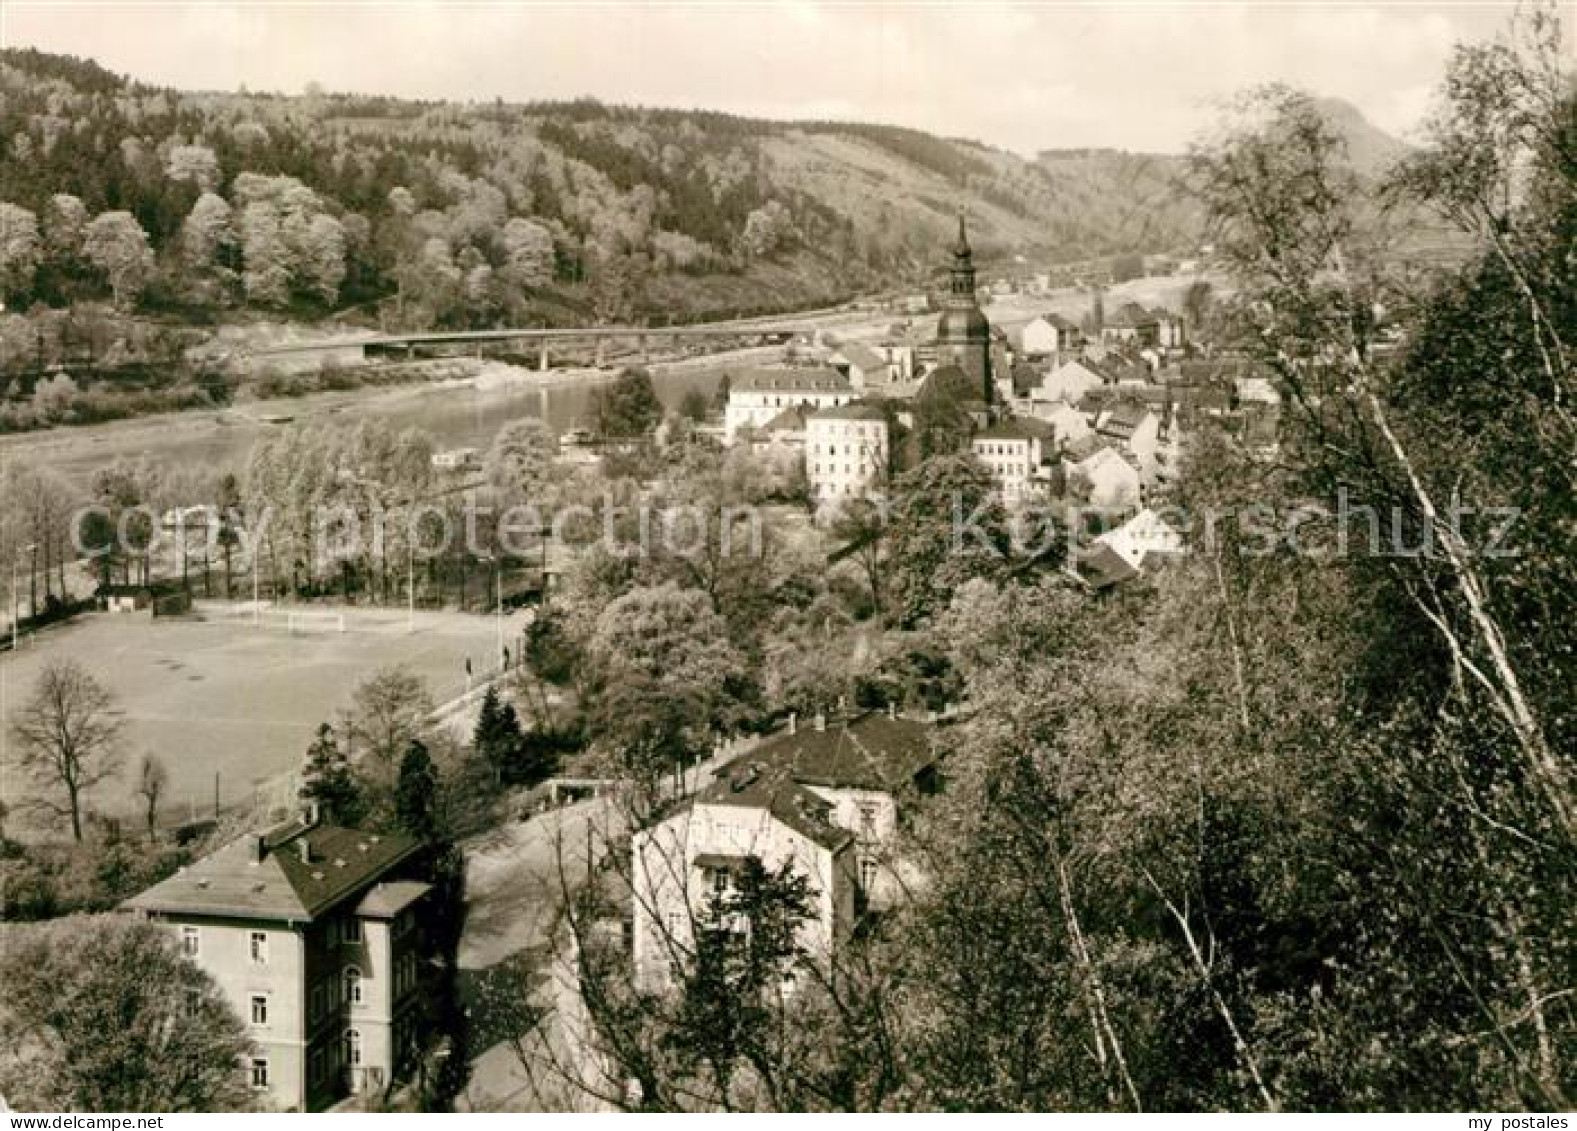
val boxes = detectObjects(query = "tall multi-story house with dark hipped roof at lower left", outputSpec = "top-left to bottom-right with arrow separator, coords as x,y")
125,816 -> 429,1110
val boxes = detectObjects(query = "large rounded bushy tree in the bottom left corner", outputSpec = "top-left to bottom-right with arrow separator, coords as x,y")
0,916 -> 251,1112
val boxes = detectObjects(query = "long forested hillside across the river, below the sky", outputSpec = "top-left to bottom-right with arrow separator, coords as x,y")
0,50 -> 1197,325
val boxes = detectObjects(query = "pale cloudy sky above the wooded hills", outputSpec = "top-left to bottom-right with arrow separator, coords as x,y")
0,0 -> 1551,155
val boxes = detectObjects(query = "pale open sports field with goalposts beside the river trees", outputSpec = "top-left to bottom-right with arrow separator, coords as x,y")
0,609 -> 524,819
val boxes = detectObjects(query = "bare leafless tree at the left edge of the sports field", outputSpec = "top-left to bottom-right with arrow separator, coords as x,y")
11,659 -> 120,842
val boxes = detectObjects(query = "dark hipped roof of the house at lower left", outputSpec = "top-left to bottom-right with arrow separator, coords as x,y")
123,822 -> 421,923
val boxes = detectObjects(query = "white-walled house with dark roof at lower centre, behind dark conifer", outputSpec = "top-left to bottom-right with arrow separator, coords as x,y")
631,711 -> 938,989
